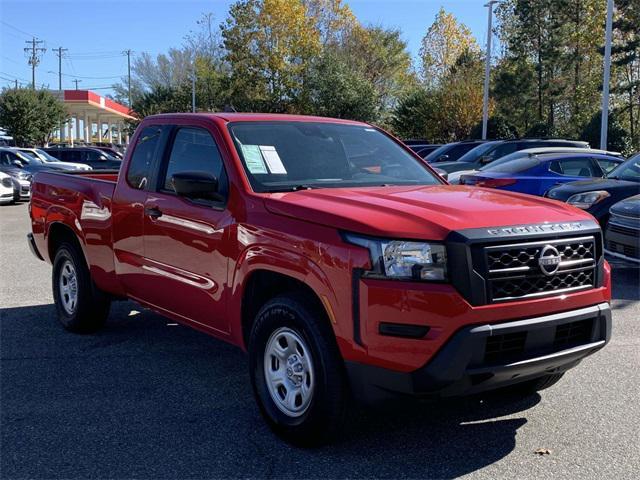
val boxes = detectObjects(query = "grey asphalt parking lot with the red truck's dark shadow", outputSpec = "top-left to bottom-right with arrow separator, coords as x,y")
0,204 -> 640,479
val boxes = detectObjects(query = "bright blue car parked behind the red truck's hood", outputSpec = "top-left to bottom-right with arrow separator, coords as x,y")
460,150 -> 624,196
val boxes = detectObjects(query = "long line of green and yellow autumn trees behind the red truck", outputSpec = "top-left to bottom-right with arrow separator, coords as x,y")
0,0 -> 640,153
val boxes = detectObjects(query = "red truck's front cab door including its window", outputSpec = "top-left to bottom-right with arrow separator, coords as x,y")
141,124 -> 233,335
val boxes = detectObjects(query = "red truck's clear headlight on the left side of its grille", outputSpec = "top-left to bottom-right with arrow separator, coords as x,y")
344,233 -> 447,282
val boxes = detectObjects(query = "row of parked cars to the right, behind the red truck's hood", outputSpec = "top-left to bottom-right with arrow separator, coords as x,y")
410,139 -> 640,262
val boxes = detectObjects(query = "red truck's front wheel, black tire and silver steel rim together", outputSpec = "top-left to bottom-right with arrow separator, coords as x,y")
249,296 -> 348,446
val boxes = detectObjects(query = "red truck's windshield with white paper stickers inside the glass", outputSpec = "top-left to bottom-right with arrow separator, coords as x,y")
229,121 -> 442,192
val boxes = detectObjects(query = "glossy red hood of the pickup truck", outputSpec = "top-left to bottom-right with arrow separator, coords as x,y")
265,185 -> 592,240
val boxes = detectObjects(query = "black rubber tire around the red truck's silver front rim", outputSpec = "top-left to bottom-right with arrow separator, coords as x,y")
248,295 -> 349,447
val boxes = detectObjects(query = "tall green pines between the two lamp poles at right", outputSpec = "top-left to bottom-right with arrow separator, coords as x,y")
494,0 -> 605,136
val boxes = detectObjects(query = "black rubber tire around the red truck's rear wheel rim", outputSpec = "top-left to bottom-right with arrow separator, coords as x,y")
52,243 -> 111,333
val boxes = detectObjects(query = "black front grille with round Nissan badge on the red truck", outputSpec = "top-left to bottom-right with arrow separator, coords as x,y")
480,236 -> 597,302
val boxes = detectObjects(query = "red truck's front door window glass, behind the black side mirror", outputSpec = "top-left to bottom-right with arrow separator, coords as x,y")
162,127 -> 226,196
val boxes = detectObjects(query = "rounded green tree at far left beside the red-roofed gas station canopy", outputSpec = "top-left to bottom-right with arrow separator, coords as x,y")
0,88 -> 68,147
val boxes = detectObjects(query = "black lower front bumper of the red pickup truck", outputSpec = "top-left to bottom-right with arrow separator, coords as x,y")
346,303 -> 611,402
